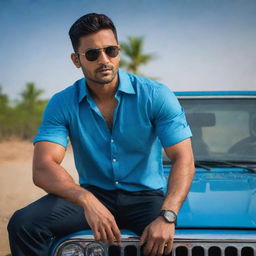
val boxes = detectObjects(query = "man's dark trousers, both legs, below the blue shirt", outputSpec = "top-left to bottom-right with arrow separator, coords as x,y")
7,187 -> 164,256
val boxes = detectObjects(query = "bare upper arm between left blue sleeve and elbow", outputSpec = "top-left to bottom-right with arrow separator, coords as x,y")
33,141 -> 66,167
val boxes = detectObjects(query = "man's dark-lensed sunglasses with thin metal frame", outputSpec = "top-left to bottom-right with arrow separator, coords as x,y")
77,45 -> 120,61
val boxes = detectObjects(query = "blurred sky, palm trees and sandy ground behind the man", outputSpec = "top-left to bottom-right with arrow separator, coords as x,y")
0,0 -> 256,256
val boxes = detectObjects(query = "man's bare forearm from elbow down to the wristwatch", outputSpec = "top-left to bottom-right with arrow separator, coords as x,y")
162,159 -> 195,213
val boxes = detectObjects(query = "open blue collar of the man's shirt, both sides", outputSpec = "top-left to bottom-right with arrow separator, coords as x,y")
78,69 -> 136,102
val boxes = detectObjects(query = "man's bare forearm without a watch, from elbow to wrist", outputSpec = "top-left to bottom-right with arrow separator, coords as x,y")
33,161 -> 91,207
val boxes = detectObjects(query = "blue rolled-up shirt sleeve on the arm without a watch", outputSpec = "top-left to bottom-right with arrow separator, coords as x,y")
34,94 -> 68,148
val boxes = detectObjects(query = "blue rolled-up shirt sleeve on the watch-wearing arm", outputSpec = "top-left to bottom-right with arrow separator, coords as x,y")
153,85 -> 192,147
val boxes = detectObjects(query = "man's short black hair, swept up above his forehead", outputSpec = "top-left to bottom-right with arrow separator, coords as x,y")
69,13 -> 118,52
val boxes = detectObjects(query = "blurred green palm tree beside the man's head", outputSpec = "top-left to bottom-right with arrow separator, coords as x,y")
120,37 -> 155,75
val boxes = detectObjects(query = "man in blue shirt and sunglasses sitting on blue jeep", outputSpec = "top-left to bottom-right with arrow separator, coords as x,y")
8,13 -> 194,256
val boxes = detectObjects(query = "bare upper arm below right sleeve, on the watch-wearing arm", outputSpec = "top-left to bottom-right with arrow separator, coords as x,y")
164,138 -> 194,161
